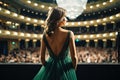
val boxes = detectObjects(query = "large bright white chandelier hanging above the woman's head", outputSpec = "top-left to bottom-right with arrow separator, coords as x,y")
56,0 -> 88,19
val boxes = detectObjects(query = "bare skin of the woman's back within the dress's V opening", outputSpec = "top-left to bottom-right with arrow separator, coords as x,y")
46,29 -> 68,56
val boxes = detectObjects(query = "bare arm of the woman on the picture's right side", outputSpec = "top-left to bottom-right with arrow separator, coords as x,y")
69,31 -> 78,69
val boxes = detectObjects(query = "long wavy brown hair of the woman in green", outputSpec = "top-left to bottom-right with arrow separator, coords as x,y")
45,7 -> 66,36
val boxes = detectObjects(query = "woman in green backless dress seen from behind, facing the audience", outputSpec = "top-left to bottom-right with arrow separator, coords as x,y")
34,7 -> 78,80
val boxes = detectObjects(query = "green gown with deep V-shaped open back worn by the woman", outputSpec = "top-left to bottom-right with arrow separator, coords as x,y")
33,32 -> 77,80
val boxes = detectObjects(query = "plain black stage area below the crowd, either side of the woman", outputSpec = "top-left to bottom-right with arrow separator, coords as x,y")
0,63 -> 120,80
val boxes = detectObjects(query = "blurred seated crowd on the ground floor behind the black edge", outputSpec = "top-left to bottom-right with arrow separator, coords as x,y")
0,47 -> 118,63
